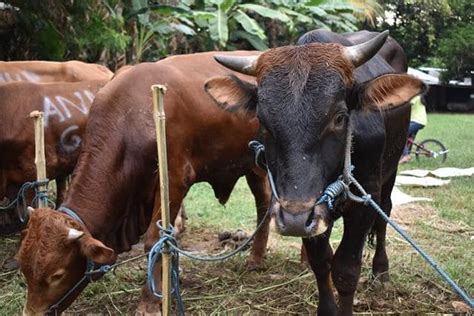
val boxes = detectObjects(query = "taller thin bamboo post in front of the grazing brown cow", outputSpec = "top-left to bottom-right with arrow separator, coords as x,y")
151,85 -> 171,316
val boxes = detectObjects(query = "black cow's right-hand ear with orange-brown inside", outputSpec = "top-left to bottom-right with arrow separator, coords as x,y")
361,74 -> 427,110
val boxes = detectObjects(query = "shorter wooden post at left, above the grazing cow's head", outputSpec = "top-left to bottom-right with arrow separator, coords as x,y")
30,111 -> 48,207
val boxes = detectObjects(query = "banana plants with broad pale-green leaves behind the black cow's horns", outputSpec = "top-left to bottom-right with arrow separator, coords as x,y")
184,0 -> 380,50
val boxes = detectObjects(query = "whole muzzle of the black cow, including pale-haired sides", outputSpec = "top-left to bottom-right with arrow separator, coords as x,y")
273,201 -> 329,238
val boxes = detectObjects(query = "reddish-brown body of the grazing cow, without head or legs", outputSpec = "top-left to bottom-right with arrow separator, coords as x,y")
64,52 -> 258,252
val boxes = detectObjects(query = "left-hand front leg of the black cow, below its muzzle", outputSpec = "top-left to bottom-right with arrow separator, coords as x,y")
303,225 -> 337,316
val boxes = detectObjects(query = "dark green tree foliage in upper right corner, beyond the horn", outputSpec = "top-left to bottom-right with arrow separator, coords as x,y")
377,0 -> 474,77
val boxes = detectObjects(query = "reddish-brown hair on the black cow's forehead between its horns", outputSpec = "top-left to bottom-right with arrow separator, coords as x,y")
256,43 -> 354,85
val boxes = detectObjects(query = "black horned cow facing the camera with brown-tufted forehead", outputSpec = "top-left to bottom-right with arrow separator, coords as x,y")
206,32 -> 425,315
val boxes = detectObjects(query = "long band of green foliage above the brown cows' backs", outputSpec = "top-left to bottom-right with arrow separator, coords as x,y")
2,0 -> 379,68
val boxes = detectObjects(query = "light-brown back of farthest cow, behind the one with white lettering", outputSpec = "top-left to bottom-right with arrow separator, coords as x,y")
0,60 -> 114,83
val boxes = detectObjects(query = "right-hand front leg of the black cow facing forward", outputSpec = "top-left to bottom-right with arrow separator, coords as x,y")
332,205 -> 375,315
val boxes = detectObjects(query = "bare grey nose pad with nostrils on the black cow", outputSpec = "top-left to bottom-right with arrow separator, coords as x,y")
275,207 -> 316,237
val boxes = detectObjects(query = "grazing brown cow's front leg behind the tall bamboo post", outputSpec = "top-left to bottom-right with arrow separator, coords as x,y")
136,183 -> 185,316
